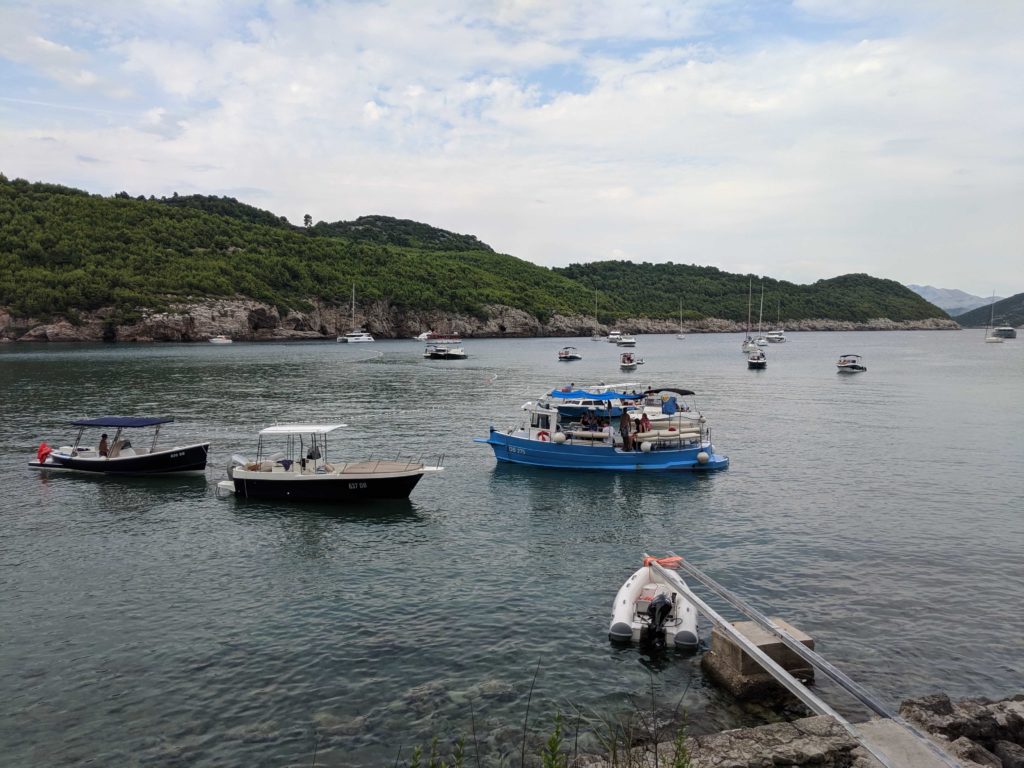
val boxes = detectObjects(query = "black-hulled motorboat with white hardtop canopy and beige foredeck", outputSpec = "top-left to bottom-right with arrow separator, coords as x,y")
217,424 -> 443,502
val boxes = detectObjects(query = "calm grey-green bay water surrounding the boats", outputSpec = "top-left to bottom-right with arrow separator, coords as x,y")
0,332 -> 1024,766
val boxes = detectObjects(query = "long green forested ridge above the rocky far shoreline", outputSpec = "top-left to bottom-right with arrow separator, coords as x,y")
0,174 -> 946,324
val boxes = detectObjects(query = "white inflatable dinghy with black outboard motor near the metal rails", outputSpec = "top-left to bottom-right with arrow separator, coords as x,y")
608,557 -> 699,650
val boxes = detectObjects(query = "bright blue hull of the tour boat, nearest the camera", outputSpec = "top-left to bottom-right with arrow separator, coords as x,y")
476,427 -> 729,472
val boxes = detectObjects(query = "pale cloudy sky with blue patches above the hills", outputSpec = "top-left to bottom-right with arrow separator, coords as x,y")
0,0 -> 1024,296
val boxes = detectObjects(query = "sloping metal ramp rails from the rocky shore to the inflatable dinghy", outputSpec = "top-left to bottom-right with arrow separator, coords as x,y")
644,552 -> 963,768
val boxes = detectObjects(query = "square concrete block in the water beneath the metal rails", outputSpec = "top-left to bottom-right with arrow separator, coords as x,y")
700,617 -> 814,700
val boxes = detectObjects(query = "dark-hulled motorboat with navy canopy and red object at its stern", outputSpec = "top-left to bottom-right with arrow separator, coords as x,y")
29,416 -> 210,475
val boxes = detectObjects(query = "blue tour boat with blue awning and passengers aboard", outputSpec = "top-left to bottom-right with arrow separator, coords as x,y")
474,387 -> 729,472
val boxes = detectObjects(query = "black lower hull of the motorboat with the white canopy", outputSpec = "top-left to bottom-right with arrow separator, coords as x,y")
232,471 -> 423,502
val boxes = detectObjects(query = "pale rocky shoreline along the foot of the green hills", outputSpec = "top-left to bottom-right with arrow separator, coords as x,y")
0,298 -> 959,342
